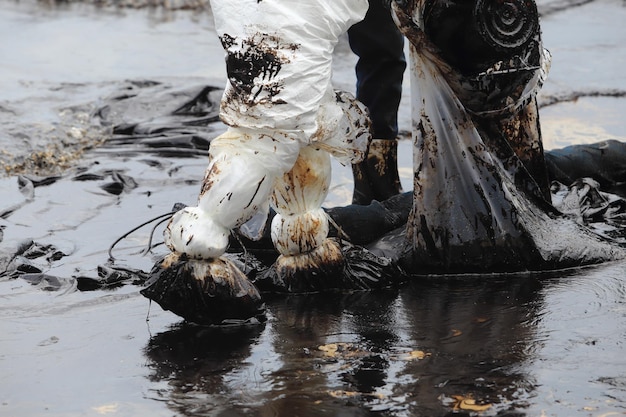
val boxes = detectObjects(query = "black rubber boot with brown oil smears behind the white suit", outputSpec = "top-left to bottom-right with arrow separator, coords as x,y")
352,139 -> 402,205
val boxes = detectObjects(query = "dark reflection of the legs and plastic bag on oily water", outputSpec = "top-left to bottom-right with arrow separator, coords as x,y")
146,276 -> 543,416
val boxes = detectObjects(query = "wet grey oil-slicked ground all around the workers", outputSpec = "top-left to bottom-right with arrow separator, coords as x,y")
0,0 -> 626,416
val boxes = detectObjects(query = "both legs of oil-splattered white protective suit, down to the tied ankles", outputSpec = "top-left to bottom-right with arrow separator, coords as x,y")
165,0 -> 369,290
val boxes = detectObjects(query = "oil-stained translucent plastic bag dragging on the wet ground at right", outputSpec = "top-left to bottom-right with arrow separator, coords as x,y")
388,1 -> 624,273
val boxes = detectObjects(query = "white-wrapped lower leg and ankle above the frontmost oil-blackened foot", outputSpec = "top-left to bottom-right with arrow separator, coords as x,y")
165,128 -> 300,259
